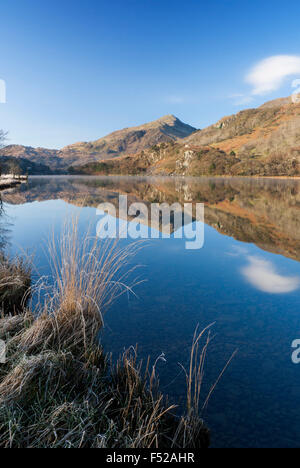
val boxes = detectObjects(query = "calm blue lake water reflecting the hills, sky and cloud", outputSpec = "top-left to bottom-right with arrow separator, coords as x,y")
2,177 -> 300,447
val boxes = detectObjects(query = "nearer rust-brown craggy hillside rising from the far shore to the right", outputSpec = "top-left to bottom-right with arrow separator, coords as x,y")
73,94 -> 300,176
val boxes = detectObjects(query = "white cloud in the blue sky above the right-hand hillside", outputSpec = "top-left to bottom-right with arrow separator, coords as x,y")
246,55 -> 300,95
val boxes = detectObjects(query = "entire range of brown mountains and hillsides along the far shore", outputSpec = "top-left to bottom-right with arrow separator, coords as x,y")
0,96 -> 300,176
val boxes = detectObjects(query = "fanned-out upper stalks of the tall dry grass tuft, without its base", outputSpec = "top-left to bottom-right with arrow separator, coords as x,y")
49,218 -> 139,315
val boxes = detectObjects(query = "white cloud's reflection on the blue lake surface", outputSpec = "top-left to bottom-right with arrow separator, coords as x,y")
242,256 -> 300,294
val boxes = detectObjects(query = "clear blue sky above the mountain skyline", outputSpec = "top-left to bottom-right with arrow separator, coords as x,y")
0,0 -> 300,148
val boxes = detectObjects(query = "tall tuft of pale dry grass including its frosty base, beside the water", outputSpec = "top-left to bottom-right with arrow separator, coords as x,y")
20,219 -> 139,354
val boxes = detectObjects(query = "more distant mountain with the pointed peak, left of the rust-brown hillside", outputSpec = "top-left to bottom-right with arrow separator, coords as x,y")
0,115 -> 196,172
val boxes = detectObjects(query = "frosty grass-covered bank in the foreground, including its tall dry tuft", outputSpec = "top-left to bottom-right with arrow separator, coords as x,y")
0,225 -> 209,448
